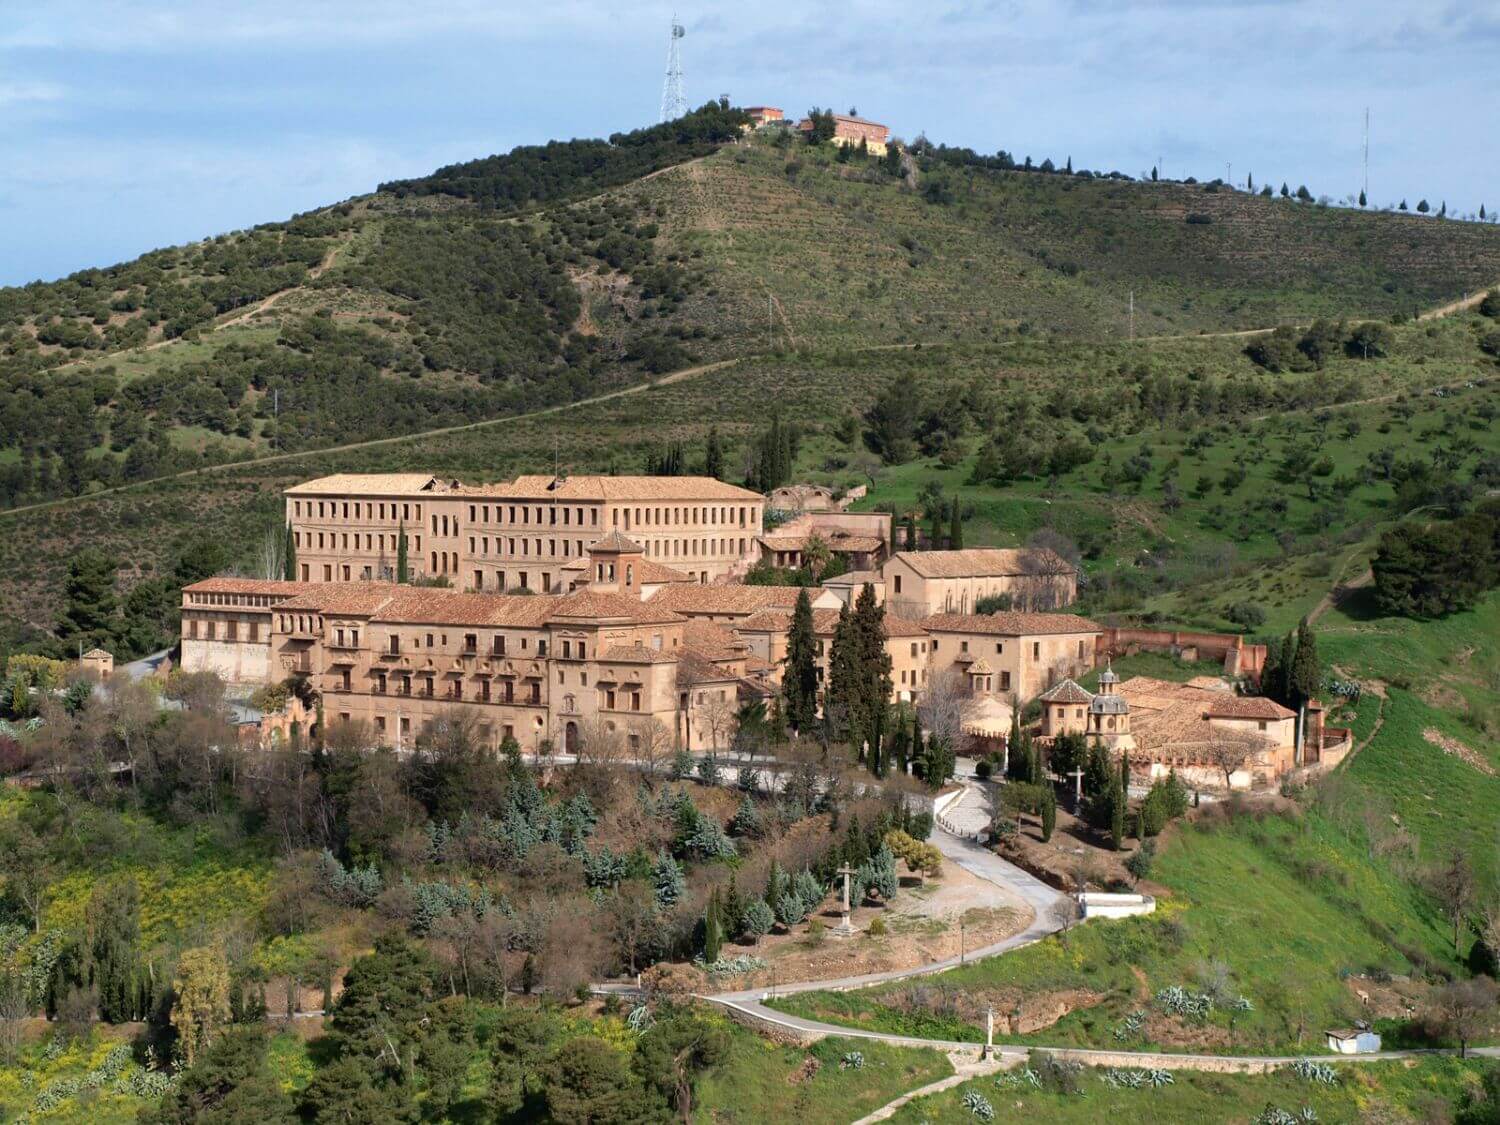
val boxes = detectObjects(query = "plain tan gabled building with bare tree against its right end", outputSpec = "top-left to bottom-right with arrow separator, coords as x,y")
881,548 -> 1079,617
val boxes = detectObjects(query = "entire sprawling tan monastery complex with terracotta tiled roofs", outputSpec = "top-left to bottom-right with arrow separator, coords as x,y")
182,473 -> 1326,785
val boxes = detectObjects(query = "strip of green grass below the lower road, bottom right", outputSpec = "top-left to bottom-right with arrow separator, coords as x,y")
891,1059 -> 1487,1125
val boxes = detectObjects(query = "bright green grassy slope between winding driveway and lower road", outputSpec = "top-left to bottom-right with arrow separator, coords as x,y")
774,812 -> 1452,1053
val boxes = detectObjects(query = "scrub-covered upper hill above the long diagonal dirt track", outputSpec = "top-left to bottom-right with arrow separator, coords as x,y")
0,104 -> 1500,519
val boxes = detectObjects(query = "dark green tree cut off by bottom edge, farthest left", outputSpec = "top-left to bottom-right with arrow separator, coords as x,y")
141,1026 -> 297,1125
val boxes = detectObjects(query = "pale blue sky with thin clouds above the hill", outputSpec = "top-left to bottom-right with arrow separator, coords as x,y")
0,0 -> 1500,285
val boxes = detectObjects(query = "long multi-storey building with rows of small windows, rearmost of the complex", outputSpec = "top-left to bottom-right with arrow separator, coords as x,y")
285,473 -> 765,594
